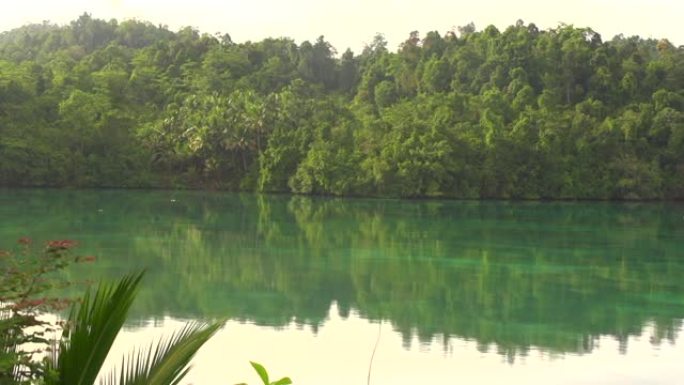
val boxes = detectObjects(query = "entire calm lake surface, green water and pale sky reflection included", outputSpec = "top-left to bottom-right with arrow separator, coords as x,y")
0,190 -> 684,385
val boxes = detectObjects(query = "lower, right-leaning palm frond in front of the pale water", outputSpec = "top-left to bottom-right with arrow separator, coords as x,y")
100,322 -> 223,385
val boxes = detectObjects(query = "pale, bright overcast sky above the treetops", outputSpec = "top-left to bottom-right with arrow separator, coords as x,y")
0,0 -> 684,53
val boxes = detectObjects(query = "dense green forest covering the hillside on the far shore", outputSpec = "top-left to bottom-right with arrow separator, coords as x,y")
0,14 -> 684,199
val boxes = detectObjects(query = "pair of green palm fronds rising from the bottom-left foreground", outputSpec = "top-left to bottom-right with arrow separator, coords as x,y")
45,273 -> 222,385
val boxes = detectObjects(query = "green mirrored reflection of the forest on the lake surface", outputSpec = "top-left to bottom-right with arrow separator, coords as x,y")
0,191 -> 684,356
